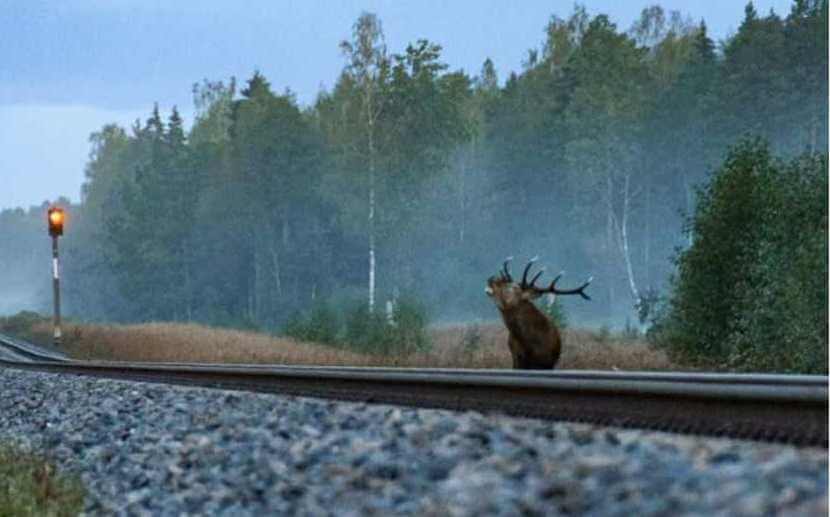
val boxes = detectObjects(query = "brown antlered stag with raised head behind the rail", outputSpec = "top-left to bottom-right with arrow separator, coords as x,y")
484,257 -> 593,370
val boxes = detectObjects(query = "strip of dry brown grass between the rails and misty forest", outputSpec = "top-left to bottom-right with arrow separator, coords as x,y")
32,323 -> 680,370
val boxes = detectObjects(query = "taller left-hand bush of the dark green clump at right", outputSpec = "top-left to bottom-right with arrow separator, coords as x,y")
652,141 -> 772,361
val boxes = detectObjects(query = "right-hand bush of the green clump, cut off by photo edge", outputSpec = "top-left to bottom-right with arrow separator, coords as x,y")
729,151 -> 828,373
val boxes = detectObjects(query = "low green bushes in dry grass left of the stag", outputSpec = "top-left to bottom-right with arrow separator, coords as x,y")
282,297 -> 430,354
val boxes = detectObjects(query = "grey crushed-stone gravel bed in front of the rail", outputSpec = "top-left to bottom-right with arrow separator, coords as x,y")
0,369 -> 828,516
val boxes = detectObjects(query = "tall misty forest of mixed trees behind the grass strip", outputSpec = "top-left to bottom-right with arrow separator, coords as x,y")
0,0 -> 828,328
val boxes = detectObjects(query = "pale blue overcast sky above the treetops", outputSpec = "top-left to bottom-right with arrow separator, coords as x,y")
0,0 -> 791,209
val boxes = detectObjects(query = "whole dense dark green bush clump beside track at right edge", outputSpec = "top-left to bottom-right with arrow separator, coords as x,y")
650,139 -> 827,373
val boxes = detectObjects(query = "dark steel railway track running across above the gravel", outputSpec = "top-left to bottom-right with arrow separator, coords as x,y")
0,335 -> 828,448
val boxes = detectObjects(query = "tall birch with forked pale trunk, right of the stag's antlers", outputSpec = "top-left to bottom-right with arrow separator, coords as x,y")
565,16 -> 648,318
